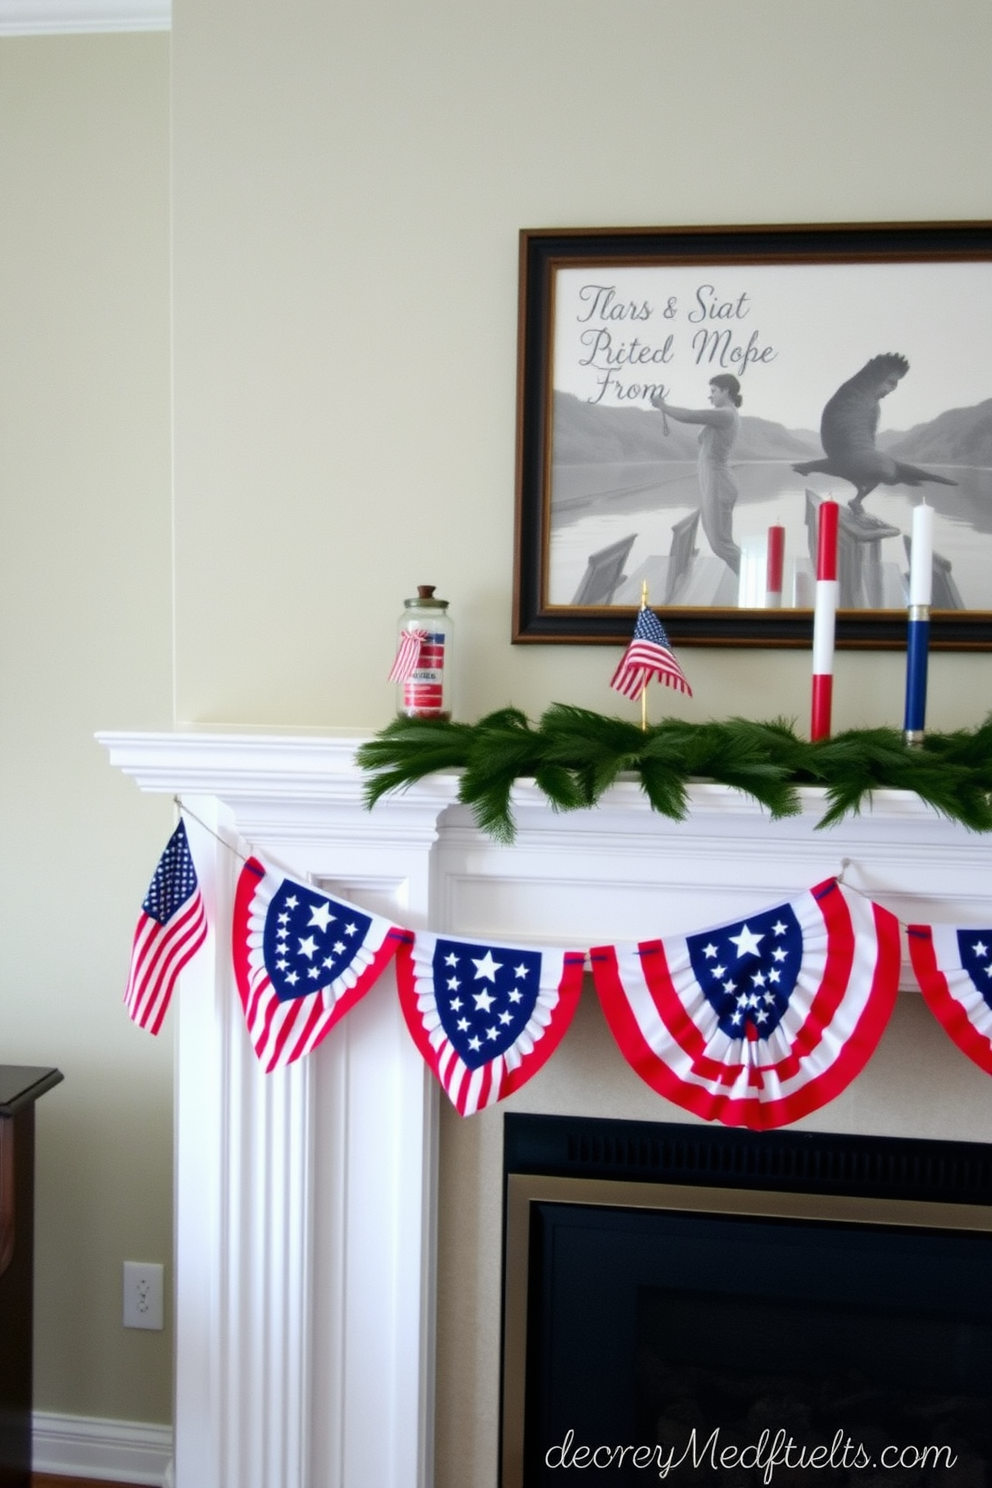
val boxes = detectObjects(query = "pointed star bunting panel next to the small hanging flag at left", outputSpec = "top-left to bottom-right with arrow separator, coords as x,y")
232,857 -> 408,1070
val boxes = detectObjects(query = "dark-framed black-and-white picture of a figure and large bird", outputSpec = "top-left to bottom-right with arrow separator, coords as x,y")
513,222 -> 992,650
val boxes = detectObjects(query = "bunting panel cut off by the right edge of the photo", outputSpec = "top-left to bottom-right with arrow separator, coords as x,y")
907,926 -> 992,1074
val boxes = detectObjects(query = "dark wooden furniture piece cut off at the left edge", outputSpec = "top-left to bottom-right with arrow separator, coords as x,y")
0,1064 -> 62,1488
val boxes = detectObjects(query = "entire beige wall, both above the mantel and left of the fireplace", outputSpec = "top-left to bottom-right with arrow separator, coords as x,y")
0,0 -> 992,1446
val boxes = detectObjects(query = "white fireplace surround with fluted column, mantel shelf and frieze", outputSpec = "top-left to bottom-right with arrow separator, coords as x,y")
98,731 -> 992,1488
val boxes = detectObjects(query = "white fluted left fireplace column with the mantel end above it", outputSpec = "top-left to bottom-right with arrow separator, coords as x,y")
104,735 -> 455,1488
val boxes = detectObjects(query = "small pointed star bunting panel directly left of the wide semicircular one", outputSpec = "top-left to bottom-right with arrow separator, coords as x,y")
396,931 -> 586,1116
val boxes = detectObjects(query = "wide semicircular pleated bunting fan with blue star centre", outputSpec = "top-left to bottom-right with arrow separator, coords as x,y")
589,879 -> 900,1129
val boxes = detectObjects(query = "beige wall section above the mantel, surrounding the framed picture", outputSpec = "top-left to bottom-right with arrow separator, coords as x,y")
173,0 -> 992,726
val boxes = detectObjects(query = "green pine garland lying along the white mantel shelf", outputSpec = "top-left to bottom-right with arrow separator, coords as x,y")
358,702 -> 992,842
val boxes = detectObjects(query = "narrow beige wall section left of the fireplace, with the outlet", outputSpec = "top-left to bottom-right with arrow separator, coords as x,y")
0,36 -> 171,1421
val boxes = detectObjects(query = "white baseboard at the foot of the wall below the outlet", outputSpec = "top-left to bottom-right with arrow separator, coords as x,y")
31,1411 -> 173,1488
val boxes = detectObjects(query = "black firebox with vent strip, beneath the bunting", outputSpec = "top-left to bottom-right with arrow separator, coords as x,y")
503,1116 -> 992,1488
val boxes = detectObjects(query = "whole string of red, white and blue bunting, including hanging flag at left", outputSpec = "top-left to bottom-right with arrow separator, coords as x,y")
125,833 -> 992,1129
